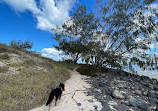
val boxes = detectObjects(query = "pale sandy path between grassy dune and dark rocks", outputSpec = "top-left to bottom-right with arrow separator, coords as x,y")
30,71 -> 102,111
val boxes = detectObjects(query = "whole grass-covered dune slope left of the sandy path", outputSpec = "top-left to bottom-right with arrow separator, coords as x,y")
0,44 -> 75,111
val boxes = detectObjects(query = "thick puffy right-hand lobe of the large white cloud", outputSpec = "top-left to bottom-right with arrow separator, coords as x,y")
37,0 -> 74,30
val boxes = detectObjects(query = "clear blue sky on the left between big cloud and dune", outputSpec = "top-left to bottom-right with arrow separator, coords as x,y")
0,0 -> 54,51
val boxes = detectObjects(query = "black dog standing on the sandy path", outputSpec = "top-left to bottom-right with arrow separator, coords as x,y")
46,83 -> 65,109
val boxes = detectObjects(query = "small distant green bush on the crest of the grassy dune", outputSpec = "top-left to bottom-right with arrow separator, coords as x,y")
10,40 -> 33,49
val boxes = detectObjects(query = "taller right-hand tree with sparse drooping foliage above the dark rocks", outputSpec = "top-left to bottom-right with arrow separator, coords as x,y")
96,0 -> 158,70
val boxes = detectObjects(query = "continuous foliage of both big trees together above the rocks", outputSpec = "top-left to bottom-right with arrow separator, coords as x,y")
53,0 -> 158,71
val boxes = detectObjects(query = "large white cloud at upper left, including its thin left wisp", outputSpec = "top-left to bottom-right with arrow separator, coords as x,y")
2,0 -> 77,31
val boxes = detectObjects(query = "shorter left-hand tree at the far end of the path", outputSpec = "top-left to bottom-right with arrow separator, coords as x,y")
52,6 -> 98,63
